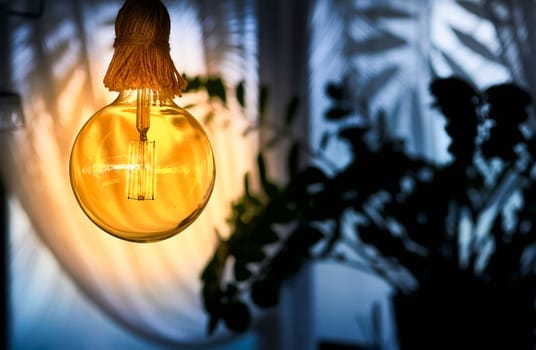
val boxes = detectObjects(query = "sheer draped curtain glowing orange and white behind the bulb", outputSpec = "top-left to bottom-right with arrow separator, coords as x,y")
0,0 -> 257,345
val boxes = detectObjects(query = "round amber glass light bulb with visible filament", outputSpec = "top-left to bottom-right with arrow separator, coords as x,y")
69,89 -> 216,242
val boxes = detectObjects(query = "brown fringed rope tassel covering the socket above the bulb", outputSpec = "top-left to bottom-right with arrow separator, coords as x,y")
104,0 -> 186,97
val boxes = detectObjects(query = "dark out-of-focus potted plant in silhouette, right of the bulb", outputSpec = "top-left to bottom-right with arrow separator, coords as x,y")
201,77 -> 536,349
